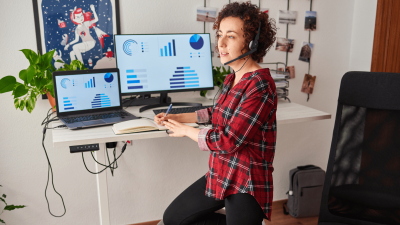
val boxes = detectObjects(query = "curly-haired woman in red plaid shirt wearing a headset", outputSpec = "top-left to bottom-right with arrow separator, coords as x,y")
154,3 -> 277,225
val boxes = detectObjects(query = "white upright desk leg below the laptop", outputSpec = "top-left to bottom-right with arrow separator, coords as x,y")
95,143 -> 110,225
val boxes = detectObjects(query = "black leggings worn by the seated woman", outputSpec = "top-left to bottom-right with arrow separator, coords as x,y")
163,176 -> 264,225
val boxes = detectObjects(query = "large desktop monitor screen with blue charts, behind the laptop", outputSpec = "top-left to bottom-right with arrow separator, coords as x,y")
115,34 -> 214,95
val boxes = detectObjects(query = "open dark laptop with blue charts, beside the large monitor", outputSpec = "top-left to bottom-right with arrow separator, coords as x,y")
53,68 -> 139,130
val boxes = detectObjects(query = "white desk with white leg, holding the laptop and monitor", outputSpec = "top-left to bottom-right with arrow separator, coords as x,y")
52,96 -> 331,225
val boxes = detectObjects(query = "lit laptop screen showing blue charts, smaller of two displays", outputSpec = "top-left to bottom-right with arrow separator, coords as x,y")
54,72 -> 120,113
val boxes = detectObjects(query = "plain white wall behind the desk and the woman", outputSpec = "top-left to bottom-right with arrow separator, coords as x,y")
0,0 -> 377,224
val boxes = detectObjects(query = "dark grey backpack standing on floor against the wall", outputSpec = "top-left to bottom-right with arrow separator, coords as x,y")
283,165 -> 325,217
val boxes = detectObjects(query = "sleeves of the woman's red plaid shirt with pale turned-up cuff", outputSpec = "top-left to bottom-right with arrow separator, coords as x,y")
198,77 -> 276,154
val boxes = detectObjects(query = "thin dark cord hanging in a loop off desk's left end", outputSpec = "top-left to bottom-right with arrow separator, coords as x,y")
41,108 -> 67,217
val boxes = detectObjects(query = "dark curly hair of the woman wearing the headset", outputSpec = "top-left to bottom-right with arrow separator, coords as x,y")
213,2 -> 276,62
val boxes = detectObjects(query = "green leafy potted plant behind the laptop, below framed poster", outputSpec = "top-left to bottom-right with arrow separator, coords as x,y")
0,49 -> 86,113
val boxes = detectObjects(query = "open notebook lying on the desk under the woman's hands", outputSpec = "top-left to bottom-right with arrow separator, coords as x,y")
112,119 -> 199,134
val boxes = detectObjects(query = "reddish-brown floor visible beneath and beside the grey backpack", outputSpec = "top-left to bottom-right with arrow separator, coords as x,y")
130,200 -> 318,225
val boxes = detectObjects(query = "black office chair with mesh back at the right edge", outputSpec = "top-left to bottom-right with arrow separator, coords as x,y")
318,72 -> 400,225
